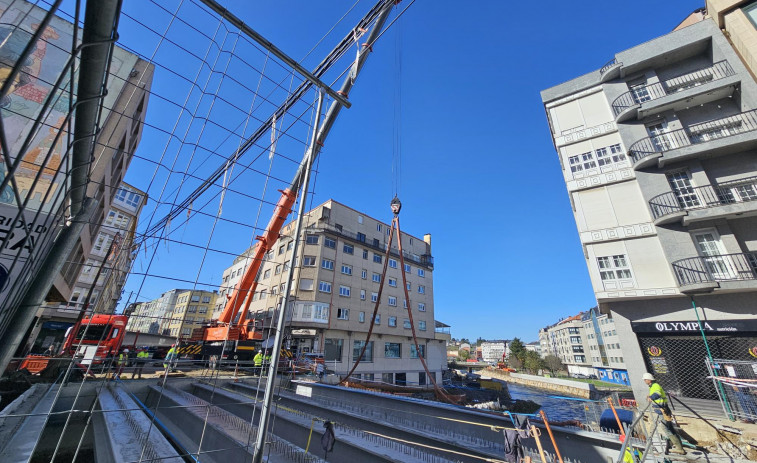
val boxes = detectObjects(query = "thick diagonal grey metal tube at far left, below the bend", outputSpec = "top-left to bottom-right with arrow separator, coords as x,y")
0,198 -> 99,372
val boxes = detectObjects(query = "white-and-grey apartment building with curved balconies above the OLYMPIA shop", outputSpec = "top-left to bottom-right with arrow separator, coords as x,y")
542,19 -> 757,400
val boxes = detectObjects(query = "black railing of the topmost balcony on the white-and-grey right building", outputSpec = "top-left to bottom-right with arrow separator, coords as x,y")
612,61 -> 735,117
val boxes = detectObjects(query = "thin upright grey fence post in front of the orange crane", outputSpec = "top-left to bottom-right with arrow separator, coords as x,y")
252,91 -> 323,463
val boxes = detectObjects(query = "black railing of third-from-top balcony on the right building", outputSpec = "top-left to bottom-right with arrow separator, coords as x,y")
649,177 -> 757,220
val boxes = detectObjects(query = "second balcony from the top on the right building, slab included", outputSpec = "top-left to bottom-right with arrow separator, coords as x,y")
628,109 -> 757,169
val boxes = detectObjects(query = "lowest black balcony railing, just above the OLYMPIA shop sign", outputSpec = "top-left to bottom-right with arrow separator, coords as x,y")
673,252 -> 757,286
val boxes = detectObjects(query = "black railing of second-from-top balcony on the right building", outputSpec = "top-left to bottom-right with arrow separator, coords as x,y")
628,109 -> 757,164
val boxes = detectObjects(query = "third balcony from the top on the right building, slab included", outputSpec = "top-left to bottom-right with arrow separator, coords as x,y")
649,177 -> 757,225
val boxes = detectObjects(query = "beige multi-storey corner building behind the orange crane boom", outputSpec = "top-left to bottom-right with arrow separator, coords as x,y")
216,200 -> 449,384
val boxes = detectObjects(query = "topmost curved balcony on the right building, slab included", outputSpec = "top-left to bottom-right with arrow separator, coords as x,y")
612,61 -> 735,122
